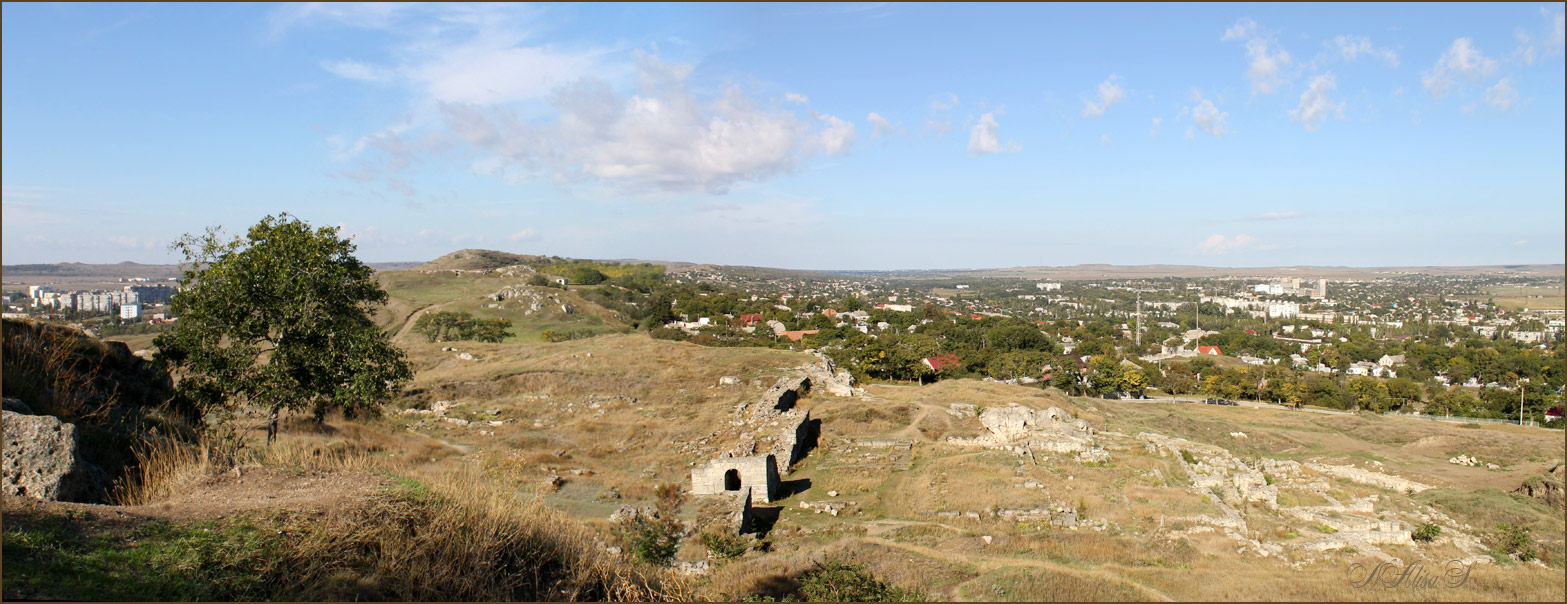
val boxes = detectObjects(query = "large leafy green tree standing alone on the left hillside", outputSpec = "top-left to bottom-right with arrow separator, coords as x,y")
155,213 -> 412,442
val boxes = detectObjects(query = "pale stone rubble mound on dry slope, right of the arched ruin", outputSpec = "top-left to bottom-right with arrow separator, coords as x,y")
946,403 -> 1109,461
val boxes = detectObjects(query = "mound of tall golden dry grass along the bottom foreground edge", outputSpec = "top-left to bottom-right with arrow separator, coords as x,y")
284,474 -> 693,601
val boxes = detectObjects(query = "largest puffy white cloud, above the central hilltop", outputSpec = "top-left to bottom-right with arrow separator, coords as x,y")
442,50 -> 854,193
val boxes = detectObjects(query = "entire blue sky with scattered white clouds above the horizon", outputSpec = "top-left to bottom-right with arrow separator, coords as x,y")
0,3 -> 1567,268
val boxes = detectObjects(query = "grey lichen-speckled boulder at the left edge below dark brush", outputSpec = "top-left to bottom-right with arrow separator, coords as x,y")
0,402 -> 110,502
